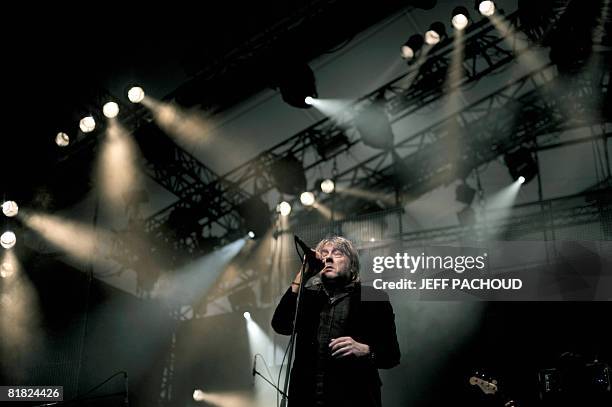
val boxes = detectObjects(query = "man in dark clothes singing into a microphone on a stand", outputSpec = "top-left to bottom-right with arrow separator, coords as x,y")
272,236 -> 400,407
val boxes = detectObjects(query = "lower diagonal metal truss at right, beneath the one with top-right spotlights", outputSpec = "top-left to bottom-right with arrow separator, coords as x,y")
314,56 -> 609,217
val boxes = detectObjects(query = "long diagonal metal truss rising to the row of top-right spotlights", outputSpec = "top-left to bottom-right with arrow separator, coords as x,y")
147,9 -> 523,239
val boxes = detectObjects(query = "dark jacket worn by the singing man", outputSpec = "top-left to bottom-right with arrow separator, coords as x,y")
272,285 -> 400,407
